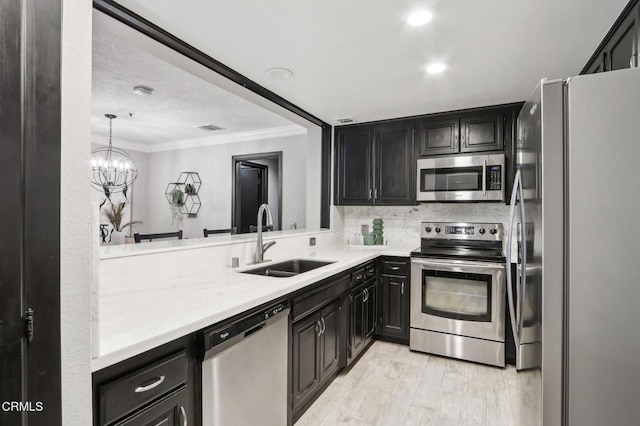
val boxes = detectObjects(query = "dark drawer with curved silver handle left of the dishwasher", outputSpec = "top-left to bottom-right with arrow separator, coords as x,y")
99,351 -> 188,425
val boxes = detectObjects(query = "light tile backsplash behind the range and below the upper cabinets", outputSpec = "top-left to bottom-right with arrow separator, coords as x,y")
334,203 -> 509,247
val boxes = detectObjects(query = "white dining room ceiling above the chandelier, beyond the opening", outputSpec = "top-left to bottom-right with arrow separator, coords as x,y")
91,11 -> 298,151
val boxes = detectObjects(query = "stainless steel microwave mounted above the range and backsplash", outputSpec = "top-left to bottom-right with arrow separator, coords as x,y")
417,154 -> 505,201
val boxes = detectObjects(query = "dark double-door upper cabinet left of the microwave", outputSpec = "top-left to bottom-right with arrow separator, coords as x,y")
335,122 -> 416,205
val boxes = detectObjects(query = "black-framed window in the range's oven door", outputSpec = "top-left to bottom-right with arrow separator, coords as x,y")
422,269 -> 493,322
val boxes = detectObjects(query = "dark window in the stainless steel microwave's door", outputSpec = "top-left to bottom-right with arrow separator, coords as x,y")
420,166 -> 482,192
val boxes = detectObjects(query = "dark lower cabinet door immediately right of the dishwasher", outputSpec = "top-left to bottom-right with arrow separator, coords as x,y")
291,314 -> 320,407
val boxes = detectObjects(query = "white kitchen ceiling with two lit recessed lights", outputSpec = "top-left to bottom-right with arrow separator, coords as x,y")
112,0 -> 628,123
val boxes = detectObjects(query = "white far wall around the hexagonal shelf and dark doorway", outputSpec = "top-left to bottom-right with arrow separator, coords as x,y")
133,135 -> 308,238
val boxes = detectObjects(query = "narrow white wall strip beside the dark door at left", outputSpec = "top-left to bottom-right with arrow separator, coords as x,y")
60,0 -> 92,425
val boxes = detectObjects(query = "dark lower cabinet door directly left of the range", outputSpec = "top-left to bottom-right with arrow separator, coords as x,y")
380,275 -> 409,338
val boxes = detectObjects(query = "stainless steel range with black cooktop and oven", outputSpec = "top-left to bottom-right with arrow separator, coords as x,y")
409,222 -> 506,367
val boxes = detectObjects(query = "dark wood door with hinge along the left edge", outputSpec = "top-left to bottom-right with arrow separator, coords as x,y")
0,0 -> 62,426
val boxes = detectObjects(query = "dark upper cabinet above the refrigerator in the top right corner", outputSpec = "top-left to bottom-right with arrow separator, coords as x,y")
580,0 -> 640,74
